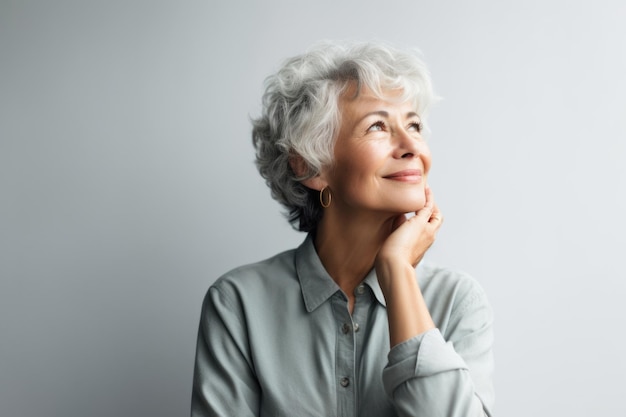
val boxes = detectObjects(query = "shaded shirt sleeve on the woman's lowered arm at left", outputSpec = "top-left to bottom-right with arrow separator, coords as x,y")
191,286 -> 260,417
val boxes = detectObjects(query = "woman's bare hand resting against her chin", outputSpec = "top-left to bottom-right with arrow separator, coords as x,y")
376,186 -> 443,268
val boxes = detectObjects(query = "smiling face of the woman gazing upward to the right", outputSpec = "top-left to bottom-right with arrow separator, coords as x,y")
322,83 -> 431,214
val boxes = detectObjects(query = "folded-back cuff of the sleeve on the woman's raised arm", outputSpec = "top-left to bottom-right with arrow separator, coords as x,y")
383,329 -> 467,396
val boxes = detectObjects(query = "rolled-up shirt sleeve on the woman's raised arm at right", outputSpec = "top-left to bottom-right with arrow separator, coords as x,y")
383,284 -> 494,417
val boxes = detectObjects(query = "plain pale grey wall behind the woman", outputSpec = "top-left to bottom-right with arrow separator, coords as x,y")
0,0 -> 626,417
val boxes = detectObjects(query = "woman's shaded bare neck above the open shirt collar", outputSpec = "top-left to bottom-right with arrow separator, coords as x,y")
315,210 -> 397,294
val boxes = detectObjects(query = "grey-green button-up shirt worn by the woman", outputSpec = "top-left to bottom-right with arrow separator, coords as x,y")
191,236 -> 494,417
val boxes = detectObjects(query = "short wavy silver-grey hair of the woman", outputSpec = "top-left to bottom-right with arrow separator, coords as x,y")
252,42 -> 433,232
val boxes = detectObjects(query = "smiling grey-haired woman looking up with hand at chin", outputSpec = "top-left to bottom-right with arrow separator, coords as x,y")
191,43 -> 494,417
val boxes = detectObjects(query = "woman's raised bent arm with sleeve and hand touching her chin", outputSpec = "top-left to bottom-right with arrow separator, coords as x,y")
376,190 -> 493,417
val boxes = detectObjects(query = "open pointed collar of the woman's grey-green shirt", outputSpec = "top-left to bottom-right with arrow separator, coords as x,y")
296,234 -> 387,313
